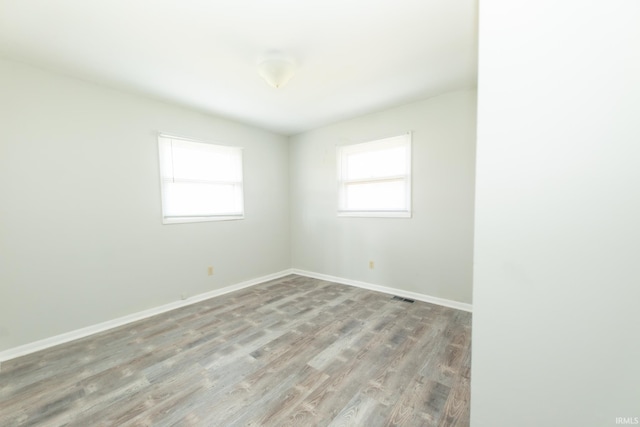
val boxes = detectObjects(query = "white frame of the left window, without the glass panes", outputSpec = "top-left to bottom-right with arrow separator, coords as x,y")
158,133 -> 244,224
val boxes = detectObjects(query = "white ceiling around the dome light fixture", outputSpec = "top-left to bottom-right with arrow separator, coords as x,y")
0,0 -> 477,135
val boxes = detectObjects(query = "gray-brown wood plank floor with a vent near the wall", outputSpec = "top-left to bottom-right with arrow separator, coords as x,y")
0,275 -> 471,427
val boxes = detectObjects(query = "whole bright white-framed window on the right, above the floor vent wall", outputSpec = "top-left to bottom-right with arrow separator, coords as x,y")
338,134 -> 411,218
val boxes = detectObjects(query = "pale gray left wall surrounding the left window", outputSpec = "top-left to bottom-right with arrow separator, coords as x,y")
0,61 -> 290,351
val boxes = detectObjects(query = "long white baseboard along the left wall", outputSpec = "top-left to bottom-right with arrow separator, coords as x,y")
0,269 -> 293,363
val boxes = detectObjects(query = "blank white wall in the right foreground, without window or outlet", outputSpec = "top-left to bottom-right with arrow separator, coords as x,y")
471,0 -> 640,427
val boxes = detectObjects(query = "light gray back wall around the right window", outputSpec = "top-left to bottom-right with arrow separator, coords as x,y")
290,90 -> 476,303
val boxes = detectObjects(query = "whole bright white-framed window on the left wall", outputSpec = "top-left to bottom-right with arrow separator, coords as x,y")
158,135 -> 244,224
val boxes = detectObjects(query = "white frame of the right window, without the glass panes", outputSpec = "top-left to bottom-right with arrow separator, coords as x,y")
336,132 -> 413,218
